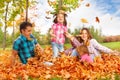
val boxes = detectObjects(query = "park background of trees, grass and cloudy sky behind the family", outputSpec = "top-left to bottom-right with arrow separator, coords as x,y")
0,0 -> 120,80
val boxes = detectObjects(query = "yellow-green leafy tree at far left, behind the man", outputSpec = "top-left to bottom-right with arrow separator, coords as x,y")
0,0 -> 35,49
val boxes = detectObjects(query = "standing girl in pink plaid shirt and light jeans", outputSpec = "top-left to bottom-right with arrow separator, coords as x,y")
50,12 -> 67,58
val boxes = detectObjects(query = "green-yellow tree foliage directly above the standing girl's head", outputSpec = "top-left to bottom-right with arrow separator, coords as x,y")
48,0 -> 80,13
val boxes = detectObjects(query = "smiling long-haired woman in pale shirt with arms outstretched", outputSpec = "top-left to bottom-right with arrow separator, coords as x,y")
66,28 -> 114,59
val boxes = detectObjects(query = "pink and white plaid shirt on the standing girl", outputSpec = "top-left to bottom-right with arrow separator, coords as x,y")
52,23 -> 67,44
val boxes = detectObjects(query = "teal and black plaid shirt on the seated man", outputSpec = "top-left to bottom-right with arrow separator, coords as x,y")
13,34 -> 37,64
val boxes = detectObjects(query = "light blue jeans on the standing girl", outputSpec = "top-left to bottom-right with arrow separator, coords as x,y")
51,42 -> 64,58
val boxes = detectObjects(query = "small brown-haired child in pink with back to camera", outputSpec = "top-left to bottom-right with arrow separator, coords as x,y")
76,45 -> 93,63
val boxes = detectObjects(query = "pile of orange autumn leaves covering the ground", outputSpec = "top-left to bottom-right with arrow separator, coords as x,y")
0,47 -> 120,80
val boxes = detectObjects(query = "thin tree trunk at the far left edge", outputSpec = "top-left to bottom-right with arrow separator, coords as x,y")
3,2 -> 9,50
